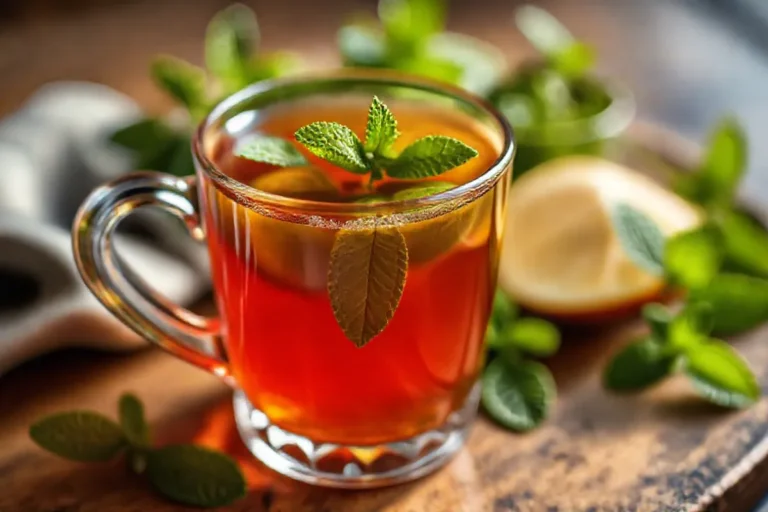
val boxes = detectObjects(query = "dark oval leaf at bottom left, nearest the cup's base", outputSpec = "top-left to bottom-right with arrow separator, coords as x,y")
146,445 -> 245,507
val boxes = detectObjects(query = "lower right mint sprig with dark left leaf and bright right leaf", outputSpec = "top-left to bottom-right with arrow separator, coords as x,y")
603,302 -> 760,408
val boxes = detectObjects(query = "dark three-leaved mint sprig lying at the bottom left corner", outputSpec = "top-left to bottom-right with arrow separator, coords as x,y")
29,394 -> 245,508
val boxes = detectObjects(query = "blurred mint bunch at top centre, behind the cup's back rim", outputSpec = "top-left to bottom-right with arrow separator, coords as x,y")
338,0 -> 503,94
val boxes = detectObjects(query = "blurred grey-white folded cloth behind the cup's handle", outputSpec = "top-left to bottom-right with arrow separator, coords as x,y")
0,82 -> 210,373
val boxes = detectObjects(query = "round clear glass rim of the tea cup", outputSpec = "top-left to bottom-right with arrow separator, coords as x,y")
192,69 -> 517,215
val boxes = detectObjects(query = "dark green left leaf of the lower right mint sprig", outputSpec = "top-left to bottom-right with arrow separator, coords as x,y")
603,338 -> 676,393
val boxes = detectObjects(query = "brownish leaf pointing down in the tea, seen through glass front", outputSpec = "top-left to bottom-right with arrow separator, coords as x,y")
328,226 -> 408,347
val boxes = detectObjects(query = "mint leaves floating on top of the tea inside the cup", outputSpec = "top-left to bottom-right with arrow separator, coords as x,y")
237,96 -> 478,186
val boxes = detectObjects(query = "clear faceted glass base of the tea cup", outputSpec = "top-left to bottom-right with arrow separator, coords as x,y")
234,385 -> 480,489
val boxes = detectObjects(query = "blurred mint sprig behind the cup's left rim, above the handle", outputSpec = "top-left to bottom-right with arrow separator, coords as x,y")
111,4 -> 297,176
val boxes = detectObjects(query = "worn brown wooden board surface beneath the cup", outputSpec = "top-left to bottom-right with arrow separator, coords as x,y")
0,316 -> 768,512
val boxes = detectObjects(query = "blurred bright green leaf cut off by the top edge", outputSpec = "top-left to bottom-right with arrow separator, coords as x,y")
379,0 -> 446,56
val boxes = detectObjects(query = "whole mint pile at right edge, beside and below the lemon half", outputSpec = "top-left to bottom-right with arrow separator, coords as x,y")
604,119 -> 768,407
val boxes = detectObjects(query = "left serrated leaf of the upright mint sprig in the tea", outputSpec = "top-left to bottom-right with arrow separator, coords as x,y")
296,121 -> 370,174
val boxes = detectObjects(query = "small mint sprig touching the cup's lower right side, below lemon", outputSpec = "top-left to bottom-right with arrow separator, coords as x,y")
482,291 -> 560,432
